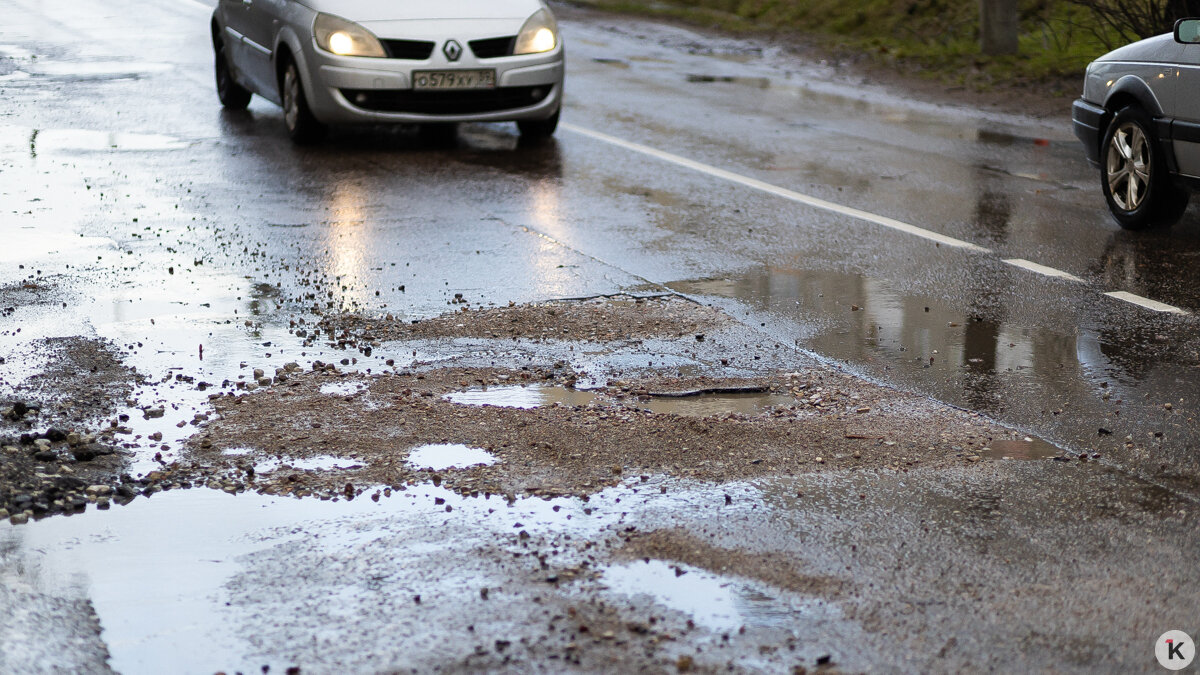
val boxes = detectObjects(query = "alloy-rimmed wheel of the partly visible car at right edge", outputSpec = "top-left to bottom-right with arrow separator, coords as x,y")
1100,106 -> 1188,229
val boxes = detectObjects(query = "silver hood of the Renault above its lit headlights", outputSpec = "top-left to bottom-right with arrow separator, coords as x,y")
304,0 -> 542,23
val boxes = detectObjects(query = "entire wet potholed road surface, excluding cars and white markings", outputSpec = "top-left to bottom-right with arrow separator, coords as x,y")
0,0 -> 1200,673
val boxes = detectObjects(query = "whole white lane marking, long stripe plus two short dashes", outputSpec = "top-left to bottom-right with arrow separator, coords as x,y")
561,121 -> 1189,315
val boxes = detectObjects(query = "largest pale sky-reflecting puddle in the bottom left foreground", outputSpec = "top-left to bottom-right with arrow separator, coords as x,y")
0,485 -> 643,675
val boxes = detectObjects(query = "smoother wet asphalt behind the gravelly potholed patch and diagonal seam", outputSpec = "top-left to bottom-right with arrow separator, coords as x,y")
0,0 -> 1200,669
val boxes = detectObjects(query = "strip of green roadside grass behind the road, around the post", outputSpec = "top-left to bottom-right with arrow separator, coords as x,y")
575,0 -> 1121,90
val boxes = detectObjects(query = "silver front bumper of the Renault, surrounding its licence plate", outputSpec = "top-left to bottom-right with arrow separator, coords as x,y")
308,47 -> 565,124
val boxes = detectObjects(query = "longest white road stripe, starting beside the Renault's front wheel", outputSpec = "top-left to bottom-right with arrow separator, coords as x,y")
558,123 -> 991,253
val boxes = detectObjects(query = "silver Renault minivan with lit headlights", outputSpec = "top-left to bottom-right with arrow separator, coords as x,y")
211,0 -> 564,142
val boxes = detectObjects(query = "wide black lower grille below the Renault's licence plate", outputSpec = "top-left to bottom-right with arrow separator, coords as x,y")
341,85 -> 552,115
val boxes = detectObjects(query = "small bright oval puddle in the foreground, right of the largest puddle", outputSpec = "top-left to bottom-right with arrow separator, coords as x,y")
601,560 -> 797,631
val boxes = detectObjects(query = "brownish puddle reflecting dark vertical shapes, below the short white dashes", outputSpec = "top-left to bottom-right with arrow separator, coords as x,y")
668,267 -> 1147,413
